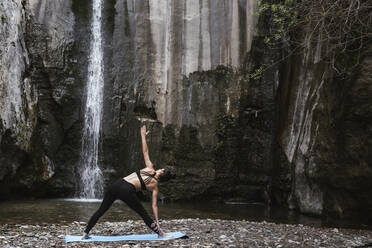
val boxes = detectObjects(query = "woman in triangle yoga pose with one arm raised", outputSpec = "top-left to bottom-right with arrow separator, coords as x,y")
83,126 -> 171,239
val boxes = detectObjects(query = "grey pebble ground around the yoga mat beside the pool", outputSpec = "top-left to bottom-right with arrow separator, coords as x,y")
0,219 -> 372,248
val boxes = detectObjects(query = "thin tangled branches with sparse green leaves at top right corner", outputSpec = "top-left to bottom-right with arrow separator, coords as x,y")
259,0 -> 372,74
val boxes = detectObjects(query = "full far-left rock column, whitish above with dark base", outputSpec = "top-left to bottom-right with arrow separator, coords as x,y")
0,1 -> 37,198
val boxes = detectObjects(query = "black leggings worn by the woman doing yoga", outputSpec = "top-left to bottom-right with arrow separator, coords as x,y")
85,178 -> 159,234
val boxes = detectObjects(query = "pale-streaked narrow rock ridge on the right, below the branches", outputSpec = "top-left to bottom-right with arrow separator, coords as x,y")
279,44 -> 332,214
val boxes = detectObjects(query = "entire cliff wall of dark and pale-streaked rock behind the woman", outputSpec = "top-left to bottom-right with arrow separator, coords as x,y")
0,0 -> 372,222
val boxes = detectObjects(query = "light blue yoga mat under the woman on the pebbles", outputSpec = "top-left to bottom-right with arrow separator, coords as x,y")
65,232 -> 187,243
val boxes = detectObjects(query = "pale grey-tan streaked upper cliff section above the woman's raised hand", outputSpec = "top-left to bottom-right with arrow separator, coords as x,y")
145,0 -> 257,127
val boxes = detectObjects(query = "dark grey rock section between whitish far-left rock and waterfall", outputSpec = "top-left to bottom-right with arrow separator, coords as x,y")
26,0 -> 80,195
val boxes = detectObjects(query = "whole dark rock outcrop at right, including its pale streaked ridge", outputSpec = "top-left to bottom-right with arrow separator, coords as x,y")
273,34 -> 372,218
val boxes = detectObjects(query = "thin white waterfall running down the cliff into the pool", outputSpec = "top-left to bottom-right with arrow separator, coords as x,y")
80,0 -> 104,198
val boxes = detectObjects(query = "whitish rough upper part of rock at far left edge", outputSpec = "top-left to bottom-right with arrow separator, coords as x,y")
0,1 -> 35,150
